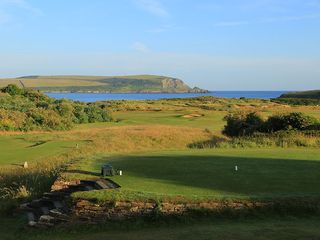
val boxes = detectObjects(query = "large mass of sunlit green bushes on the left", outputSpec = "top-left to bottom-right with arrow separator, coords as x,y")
0,85 -> 112,131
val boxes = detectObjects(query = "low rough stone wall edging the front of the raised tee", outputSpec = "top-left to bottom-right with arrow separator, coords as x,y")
73,200 -> 273,222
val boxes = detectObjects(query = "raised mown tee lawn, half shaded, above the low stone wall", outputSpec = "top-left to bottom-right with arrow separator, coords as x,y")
74,148 -> 320,200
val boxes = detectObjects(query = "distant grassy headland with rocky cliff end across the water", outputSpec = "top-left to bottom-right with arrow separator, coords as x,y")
0,75 -> 206,93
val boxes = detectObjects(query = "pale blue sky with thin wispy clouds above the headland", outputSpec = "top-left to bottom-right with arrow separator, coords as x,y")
0,0 -> 320,90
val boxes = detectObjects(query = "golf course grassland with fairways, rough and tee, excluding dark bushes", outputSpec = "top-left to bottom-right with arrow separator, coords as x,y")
0,87 -> 320,239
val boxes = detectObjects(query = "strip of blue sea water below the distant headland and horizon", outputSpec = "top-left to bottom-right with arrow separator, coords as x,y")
46,91 -> 286,102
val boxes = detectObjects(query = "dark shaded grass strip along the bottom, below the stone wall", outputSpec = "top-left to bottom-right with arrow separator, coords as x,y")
0,218 -> 320,240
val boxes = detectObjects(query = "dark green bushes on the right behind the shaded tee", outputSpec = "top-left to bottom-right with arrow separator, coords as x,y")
223,112 -> 320,137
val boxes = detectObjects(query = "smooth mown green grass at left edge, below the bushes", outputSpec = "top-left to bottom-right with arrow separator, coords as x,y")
0,135 -> 76,165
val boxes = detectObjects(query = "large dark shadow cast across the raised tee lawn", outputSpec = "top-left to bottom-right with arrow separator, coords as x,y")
93,155 -> 320,197
